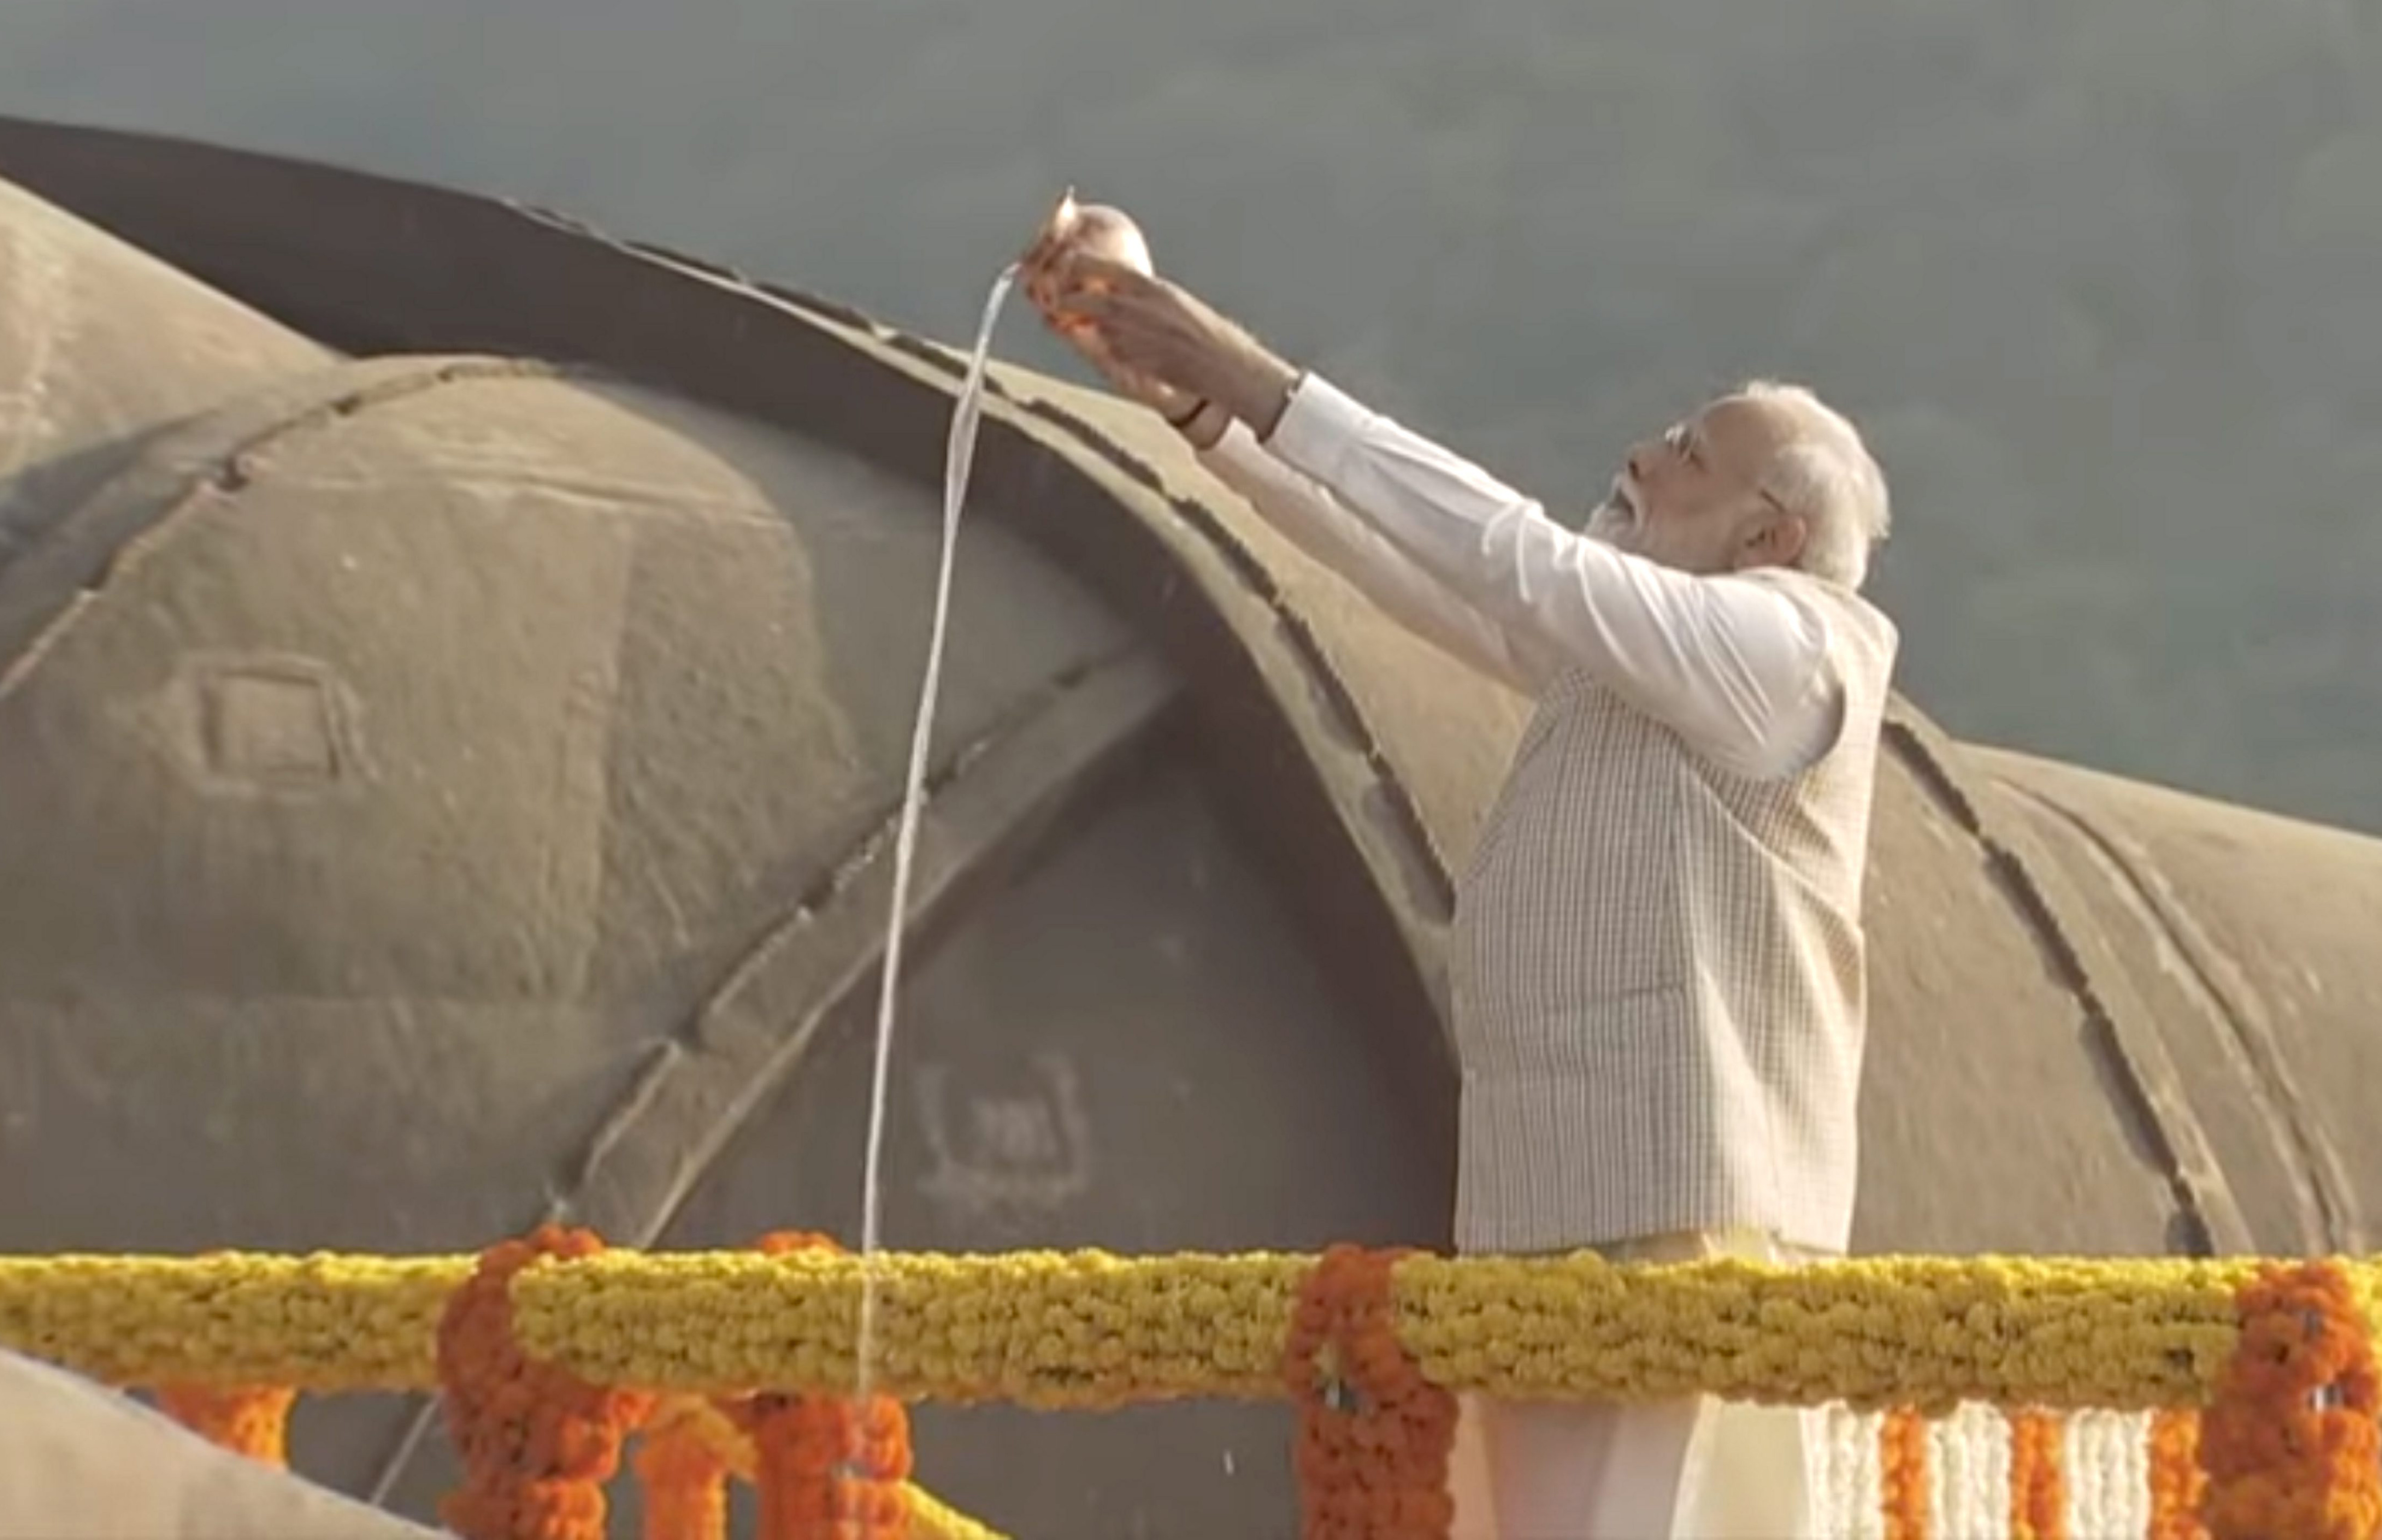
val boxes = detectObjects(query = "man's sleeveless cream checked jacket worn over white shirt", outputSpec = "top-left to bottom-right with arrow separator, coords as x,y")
1451,570 -> 1896,1252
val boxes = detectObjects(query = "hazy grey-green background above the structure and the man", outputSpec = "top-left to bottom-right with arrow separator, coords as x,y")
0,0 -> 2382,830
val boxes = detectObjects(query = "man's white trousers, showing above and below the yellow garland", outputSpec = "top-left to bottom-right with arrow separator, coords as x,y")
1448,1235 -> 1822,1540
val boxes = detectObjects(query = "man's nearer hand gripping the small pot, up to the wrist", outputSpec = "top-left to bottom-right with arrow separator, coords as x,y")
1051,250 -> 1298,439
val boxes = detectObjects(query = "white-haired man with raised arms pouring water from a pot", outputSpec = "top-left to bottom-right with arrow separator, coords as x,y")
1027,232 -> 1896,1540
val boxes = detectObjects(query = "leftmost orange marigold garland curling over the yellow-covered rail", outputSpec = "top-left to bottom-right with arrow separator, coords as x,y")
438,1225 -> 653,1540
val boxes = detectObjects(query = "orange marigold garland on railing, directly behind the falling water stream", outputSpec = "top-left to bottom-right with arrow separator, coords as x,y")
729,1230 -> 912,1540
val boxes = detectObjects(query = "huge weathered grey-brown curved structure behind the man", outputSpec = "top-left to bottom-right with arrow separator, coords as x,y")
0,122 -> 2382,1535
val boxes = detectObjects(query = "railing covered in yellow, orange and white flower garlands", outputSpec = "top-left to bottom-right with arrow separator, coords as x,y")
0,1230 -> 2382,1540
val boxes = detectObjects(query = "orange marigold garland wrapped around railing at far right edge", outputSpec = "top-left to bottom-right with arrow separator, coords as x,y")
2201,1261 -> 2382,1540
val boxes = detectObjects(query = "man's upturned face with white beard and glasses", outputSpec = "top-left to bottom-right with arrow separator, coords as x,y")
1587,396 -> 1803,572
